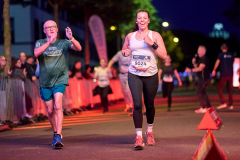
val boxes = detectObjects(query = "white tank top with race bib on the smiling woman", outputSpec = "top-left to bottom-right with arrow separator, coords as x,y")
129,31 -> 158,76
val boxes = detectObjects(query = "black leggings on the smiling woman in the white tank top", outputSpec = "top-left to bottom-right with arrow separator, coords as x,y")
128,73 -> 158,128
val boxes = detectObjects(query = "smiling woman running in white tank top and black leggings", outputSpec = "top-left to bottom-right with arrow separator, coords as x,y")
122,10 -> 167,149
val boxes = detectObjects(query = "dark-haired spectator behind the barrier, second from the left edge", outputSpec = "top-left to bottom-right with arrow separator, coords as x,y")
10,58 -> 27,81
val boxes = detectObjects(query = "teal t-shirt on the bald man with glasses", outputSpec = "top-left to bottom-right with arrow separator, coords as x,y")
35,39 -> 72,88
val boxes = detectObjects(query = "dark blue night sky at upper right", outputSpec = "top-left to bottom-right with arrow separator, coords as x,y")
152,0 -> 240,38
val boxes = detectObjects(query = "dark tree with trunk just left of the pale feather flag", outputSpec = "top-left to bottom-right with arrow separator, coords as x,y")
66,0 -> 135,65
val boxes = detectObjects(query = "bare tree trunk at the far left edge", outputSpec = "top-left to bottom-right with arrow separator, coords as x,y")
3,0 -> 12,72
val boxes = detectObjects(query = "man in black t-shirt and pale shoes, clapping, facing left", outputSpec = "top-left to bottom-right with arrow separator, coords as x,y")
185,45 -> 211,113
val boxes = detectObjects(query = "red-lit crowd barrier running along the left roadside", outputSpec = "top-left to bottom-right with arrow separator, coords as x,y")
0,79 -> 123,121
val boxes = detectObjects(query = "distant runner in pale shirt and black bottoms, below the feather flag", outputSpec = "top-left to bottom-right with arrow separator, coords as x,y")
93,59 -> 112,113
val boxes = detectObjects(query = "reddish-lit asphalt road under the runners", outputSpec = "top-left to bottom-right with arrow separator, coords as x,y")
0,91 -> 240,160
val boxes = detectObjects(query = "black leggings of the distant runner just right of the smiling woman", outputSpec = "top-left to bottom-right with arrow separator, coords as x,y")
162,81 -> 174,108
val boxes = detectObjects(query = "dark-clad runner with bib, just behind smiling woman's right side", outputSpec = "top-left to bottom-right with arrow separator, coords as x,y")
158,56 -> 182,111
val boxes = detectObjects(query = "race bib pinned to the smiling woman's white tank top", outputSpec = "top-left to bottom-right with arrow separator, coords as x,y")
132,55 -> 151,71
